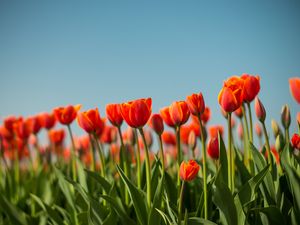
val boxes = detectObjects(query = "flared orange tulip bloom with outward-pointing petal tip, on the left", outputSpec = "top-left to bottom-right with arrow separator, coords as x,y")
54,105 -> 81,125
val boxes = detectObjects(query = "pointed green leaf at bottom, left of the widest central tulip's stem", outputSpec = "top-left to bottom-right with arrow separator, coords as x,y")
117,165 -> 148,225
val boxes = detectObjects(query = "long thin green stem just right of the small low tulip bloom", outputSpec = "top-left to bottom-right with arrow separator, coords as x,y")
198,115 -> 207,219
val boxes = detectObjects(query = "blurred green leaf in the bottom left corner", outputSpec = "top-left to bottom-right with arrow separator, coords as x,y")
0,194 -> 28,225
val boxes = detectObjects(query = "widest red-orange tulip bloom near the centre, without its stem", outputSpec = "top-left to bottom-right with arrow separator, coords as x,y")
121,98 -> 152,128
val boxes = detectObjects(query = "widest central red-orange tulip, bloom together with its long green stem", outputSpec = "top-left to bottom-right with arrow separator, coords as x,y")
121,98 -> 152,207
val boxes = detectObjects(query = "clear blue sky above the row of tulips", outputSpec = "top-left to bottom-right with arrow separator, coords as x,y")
0,0 -> 300,142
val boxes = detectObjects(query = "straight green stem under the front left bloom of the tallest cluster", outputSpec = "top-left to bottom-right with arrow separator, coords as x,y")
227,113 -> 235,193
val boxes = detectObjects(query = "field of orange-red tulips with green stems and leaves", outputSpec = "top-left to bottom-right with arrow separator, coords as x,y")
0,74 -> 300,225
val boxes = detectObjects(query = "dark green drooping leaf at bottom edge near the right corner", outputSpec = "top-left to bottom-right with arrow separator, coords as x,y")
251,206 -> 286,225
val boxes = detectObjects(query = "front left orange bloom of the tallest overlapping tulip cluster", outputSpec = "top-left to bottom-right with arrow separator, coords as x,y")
218,76 -> 244,113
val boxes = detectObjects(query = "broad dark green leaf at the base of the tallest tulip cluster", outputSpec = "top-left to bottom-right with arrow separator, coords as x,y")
213,167 -> 238,225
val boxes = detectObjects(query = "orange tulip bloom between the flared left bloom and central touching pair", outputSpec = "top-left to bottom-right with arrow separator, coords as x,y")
77,108 -> 104,133
